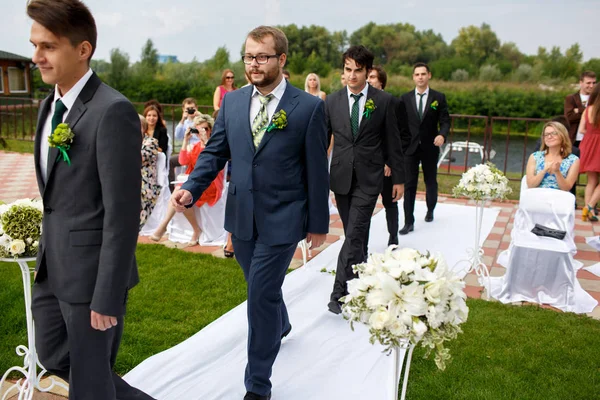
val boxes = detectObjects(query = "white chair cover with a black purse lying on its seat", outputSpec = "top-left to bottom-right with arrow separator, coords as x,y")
489,186 -> 598,313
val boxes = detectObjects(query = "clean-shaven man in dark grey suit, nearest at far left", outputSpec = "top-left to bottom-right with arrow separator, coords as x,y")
27,0 -> 151,400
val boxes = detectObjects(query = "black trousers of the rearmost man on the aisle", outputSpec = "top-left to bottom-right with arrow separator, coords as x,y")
404,147 -> 440,225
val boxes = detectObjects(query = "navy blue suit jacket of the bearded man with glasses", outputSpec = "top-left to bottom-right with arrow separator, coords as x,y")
182,82 -> 329,246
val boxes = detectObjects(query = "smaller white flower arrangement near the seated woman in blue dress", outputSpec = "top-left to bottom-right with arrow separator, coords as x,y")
452,163 -> 512,200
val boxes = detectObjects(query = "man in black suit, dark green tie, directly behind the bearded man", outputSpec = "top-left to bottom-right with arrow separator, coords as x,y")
325,46 -> 404,314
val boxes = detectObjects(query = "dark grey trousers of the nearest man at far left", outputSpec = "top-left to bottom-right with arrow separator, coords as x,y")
31,279 -> 153,400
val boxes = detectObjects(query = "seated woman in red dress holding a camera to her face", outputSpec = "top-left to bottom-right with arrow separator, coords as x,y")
150,114 -> 224,245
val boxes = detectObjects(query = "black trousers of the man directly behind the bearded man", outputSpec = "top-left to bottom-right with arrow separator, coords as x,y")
331,174 -> 379,301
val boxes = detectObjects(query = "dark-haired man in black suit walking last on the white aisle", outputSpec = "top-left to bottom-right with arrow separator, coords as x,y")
400,63 -> 450,235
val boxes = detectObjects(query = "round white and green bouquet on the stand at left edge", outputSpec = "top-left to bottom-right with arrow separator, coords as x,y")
0,199 -> 43,258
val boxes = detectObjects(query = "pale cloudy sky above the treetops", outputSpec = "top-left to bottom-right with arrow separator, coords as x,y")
0,0 -> 600,62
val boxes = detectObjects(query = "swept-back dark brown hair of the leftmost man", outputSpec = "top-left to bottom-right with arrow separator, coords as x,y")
27,0 -> 98,63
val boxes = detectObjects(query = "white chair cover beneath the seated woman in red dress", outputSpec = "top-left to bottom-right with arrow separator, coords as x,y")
167,177 -> 228,246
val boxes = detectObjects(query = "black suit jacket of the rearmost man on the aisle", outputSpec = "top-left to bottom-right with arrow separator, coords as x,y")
401,88 -> 450,155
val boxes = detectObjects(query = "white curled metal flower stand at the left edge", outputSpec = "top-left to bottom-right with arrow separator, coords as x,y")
0,258 -> 68,400
